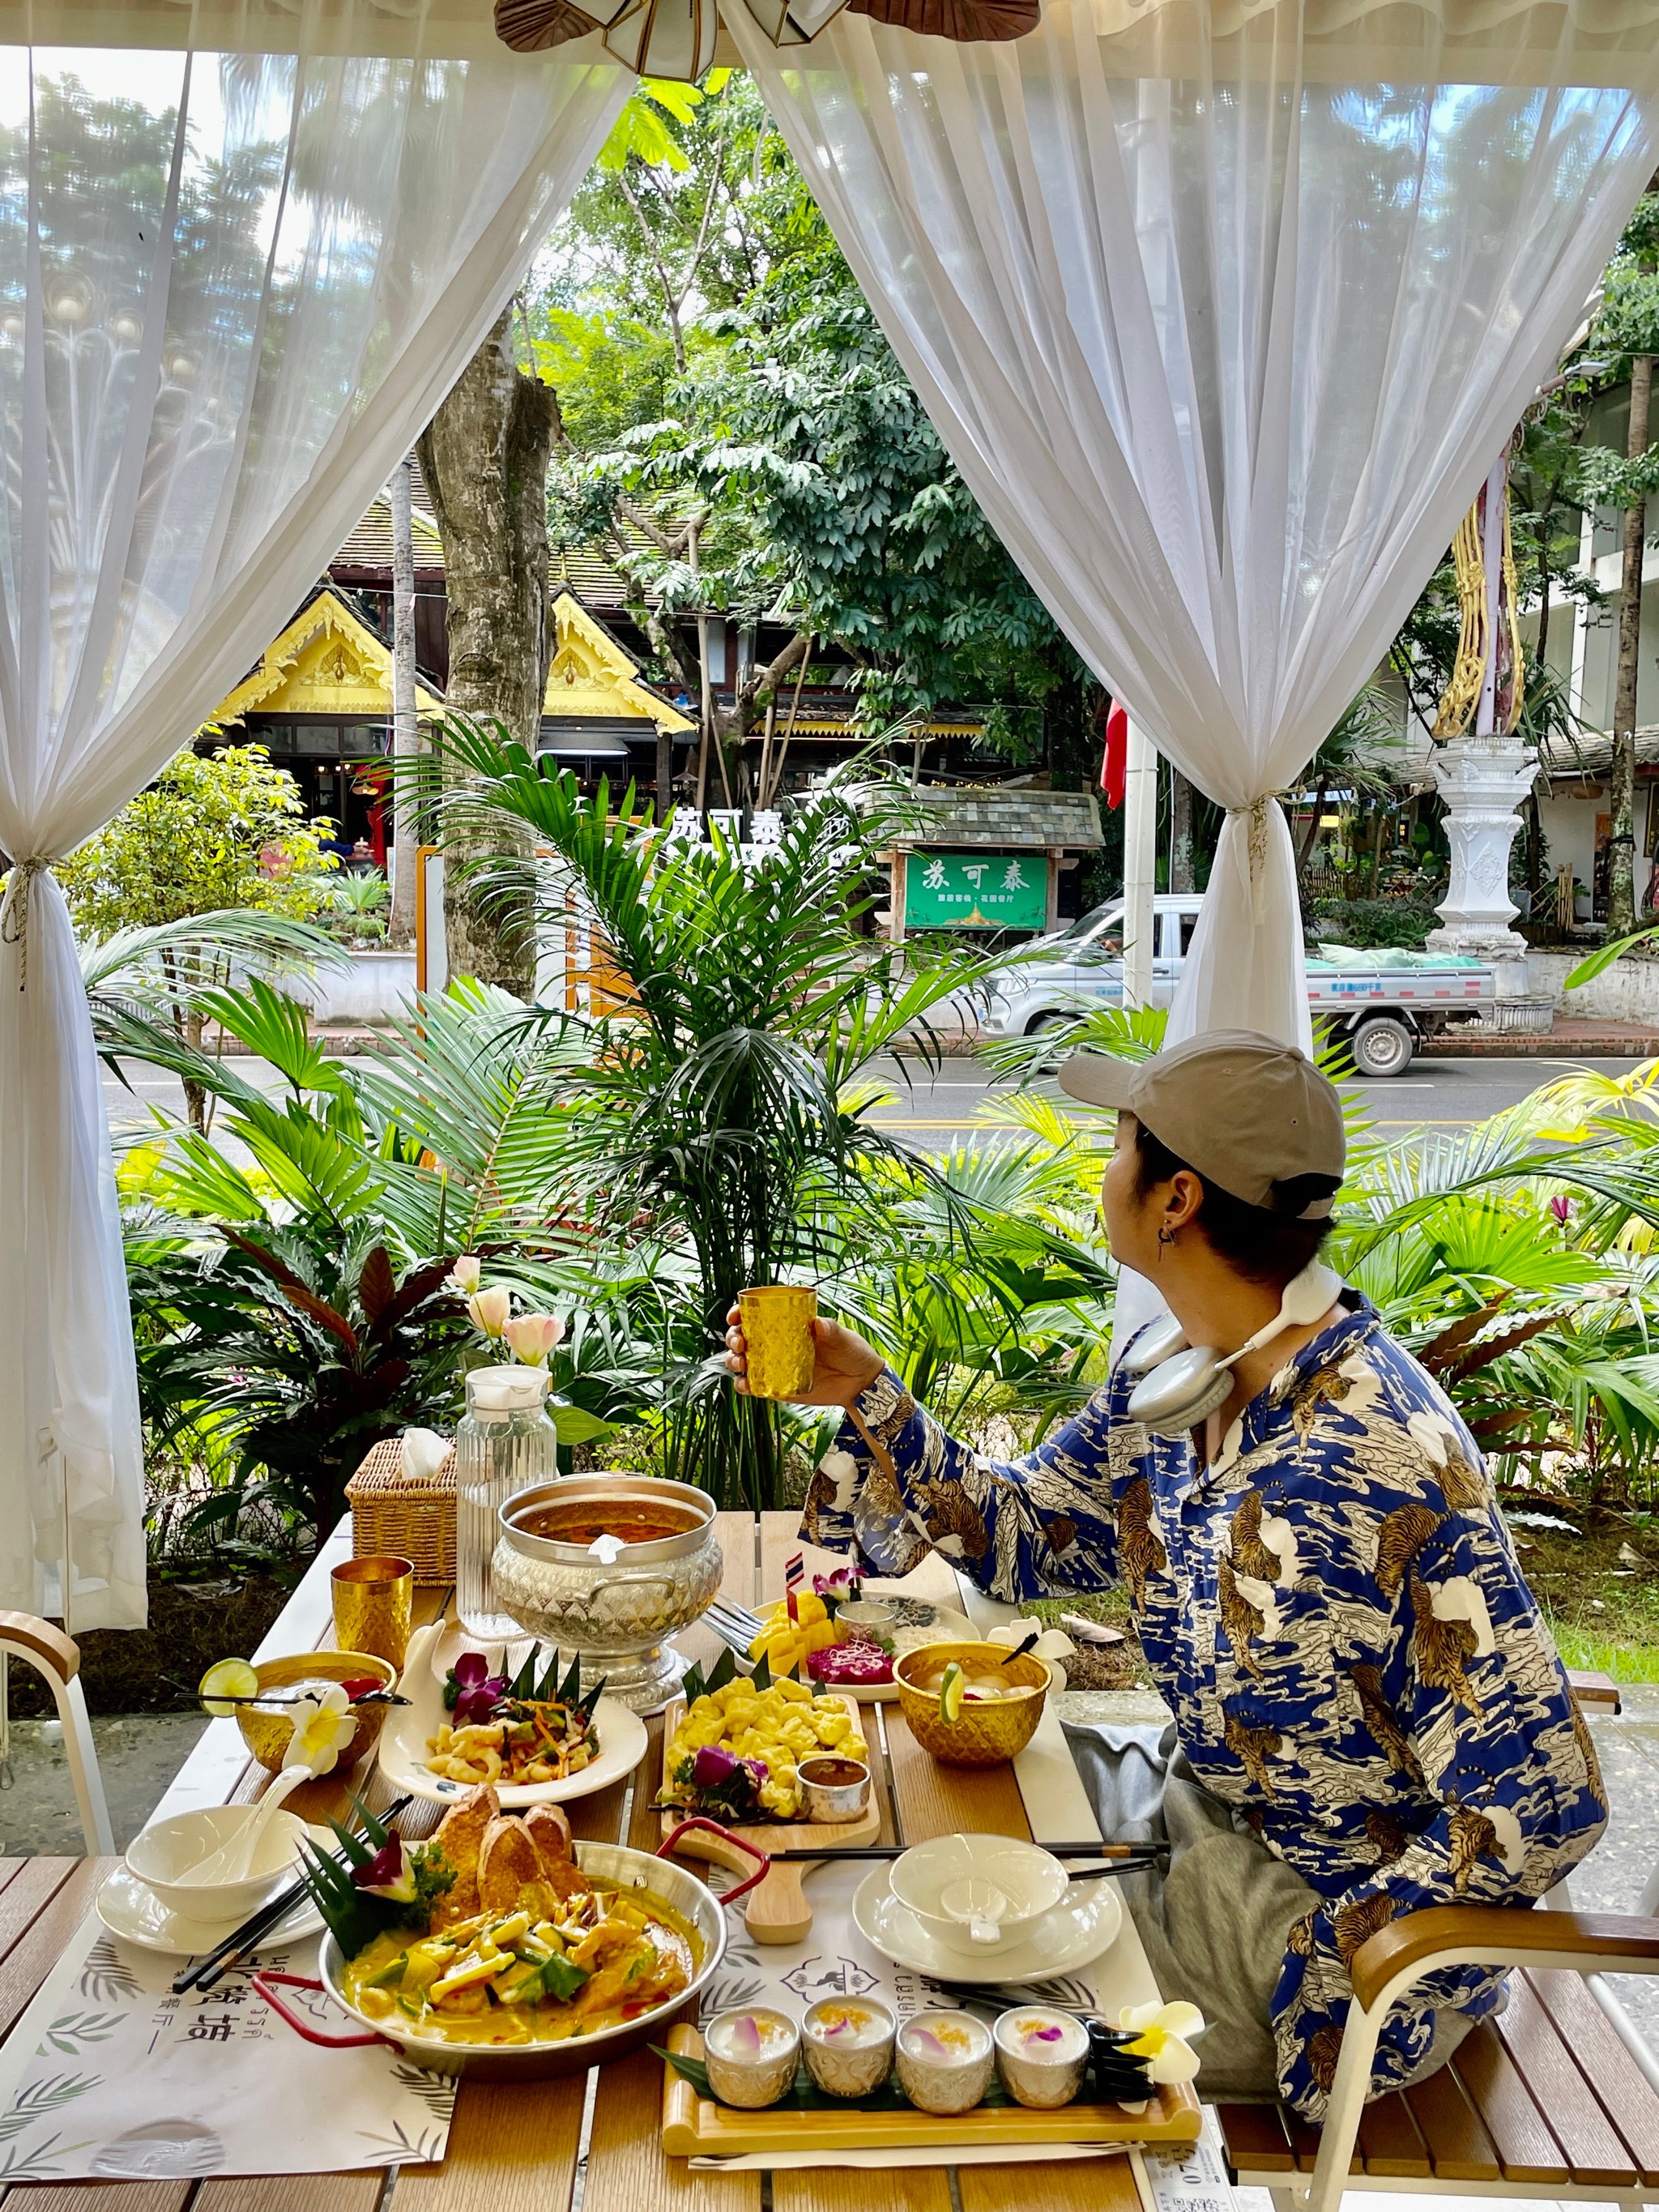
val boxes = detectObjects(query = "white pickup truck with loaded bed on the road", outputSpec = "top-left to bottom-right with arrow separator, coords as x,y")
960,891 -> 1498,1075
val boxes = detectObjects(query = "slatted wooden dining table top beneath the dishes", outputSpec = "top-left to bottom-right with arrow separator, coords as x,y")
0,1513 -> 1154,2212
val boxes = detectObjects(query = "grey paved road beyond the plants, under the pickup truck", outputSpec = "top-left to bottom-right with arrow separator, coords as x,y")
104,1060 -> 1632,1151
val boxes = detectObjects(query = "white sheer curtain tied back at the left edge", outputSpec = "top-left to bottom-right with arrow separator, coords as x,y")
0,17 -> 630,1628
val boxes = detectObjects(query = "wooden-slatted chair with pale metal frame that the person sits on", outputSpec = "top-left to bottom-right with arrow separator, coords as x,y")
1199,1675 -> 1659,2212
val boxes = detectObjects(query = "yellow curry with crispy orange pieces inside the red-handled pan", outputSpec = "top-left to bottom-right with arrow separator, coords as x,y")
316,1787 -> 703,2048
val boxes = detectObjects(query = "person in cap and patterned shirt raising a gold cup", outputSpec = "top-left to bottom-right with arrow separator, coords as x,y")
727,1031 -> 1606,2119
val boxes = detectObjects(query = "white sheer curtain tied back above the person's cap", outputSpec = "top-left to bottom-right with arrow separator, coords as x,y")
727,0 -> 1659,1044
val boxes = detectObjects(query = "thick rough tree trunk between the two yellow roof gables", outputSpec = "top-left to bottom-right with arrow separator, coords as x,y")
420,310 -> 557,997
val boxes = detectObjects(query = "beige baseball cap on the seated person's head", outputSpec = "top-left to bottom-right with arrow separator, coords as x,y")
1060,1028 -> 1347,1221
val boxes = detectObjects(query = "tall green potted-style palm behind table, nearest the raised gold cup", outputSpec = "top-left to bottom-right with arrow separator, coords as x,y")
416,719 -> 1013,1509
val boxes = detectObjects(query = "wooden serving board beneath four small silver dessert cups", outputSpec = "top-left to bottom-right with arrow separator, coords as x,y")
661,2026 -> 1203,2166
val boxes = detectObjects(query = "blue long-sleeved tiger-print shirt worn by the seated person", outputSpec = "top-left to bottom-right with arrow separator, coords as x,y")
803,1292 -> 1606,2119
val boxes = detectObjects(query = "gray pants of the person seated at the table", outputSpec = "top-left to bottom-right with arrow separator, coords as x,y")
1066,1723 -> 1469,2103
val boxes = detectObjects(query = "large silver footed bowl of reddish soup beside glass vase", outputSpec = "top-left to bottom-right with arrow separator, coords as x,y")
491,1473 -> 723,1712
